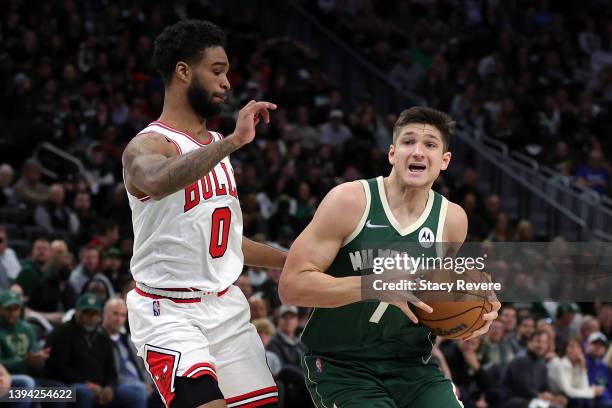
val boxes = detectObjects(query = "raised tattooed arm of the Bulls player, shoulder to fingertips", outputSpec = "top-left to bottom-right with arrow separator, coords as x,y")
122,101 -> 276,200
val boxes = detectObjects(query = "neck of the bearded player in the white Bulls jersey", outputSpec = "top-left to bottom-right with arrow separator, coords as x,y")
157,92 -> 210,142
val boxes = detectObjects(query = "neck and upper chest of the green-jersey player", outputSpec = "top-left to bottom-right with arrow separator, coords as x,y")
383,174 -> 431,220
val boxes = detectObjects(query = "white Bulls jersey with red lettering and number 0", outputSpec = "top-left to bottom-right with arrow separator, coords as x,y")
128,122 -> 244,291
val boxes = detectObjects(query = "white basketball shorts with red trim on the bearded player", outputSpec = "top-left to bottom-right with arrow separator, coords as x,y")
127,286 -> 278,408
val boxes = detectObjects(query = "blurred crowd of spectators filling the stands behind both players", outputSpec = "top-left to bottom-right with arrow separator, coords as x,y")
0,0 -> 612,408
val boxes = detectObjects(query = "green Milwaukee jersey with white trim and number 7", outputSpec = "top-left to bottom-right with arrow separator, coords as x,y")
302,177 -> 448,363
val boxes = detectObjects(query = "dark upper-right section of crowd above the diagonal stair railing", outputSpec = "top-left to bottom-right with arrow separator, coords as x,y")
310,0 -> 612,194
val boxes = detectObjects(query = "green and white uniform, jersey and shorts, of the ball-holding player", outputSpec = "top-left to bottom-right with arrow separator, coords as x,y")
302,177 -> 461,408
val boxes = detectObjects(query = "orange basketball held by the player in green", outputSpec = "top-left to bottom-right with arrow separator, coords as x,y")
414,270 -> 493,339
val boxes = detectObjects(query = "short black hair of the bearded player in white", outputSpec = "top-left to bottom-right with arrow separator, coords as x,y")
151,20 -> 226,84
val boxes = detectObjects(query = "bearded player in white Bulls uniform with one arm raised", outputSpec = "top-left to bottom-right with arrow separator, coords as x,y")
123,20 -> 285,408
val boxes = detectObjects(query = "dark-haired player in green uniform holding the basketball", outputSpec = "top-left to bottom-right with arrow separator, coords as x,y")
279,107 -> 500,408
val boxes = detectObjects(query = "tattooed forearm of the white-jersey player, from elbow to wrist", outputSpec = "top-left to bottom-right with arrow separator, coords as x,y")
140,136 -> 239,199
